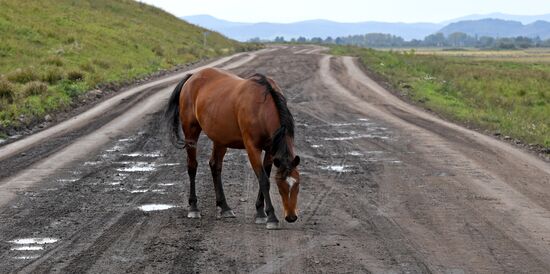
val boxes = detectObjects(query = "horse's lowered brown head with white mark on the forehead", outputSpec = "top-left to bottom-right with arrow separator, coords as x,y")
273,156 -> 300,223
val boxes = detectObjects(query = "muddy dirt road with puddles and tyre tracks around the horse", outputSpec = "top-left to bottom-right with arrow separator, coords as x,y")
0,47 -> 550,273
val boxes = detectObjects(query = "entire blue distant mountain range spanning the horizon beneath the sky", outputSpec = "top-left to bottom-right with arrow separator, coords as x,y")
182,13 -> 550,41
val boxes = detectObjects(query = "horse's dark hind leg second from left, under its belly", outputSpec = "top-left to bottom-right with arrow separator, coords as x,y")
209,144 -> 235,218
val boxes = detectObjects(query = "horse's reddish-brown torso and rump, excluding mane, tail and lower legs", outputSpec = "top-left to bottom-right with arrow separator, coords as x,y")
181,68 -> 271,148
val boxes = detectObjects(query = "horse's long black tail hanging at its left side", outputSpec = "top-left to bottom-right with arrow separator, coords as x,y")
164,74 -> 192,149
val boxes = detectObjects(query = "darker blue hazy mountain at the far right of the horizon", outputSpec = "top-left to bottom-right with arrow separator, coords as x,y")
439,19 -> 550,39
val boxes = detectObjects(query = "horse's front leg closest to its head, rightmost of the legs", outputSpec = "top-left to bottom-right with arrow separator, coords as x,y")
245,140 -> 279,229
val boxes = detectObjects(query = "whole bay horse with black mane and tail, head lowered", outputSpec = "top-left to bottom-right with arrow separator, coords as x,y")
165,68 -> 300,229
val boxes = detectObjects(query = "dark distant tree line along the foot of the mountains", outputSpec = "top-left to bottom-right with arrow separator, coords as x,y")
250,32 -> 550,49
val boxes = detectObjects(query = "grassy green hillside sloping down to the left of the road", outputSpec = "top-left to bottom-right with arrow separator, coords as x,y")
0,0 -> 258,134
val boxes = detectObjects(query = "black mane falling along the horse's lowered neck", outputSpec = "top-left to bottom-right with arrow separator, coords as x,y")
249,73 -> 294,160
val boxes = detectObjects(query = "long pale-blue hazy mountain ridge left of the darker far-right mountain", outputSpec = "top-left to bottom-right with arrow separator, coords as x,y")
183,15 -> 443,41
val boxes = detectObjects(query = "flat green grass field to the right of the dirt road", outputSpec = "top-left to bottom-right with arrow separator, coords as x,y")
332,47 -> 550,148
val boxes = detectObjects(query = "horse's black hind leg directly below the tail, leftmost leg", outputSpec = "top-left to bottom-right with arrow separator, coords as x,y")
183,125 -> 202,219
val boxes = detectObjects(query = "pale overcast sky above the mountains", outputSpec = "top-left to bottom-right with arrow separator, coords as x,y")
141,0 -> 550,23
